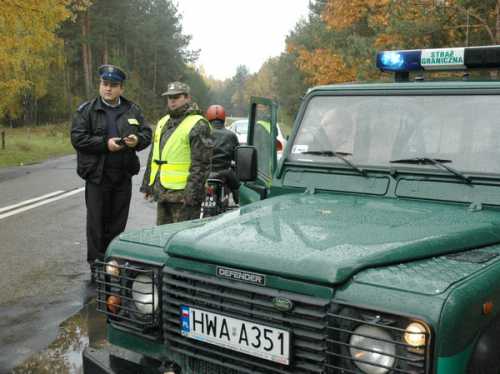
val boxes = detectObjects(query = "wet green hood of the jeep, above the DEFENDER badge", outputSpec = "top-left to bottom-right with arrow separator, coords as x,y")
166,194 -> 500,283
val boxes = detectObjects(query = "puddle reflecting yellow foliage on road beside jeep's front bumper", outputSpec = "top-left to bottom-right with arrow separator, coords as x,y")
12,301 -> 106,374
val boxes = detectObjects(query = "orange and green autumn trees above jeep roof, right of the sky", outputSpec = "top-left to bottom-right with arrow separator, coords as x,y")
280,0 -> 500,91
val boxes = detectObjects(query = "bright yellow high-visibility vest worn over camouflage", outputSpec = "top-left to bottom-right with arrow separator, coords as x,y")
149,115 -> 203,190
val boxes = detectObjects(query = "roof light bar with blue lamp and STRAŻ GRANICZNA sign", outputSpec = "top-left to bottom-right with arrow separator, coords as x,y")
377,45 -> 500,73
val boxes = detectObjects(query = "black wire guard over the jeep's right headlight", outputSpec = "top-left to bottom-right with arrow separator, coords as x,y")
327,305 -> 431,374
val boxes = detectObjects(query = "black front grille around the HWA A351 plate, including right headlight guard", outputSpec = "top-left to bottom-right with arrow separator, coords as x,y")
162,268 -> 431,374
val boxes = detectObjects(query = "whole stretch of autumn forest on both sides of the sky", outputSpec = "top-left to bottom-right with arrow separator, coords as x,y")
0,0 -> 500,132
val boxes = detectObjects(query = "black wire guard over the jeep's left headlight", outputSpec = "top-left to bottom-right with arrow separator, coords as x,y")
96,261 -> 161,339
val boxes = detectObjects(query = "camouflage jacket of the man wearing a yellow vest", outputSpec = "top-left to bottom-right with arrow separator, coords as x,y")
141,103 -> 213,206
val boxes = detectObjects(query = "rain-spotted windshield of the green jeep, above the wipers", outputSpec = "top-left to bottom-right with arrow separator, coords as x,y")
289,95 -> 500,173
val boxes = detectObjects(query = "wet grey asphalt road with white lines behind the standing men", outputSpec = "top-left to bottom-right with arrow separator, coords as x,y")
0,149 -> 156,373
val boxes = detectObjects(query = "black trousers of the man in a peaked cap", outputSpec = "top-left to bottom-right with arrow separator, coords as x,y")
85,174 -> 132,263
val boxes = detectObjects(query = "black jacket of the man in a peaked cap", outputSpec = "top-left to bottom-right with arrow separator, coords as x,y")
71,97 -> 151,183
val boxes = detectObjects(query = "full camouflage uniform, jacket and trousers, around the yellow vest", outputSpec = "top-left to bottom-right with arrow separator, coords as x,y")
141,103 -> 213,225
